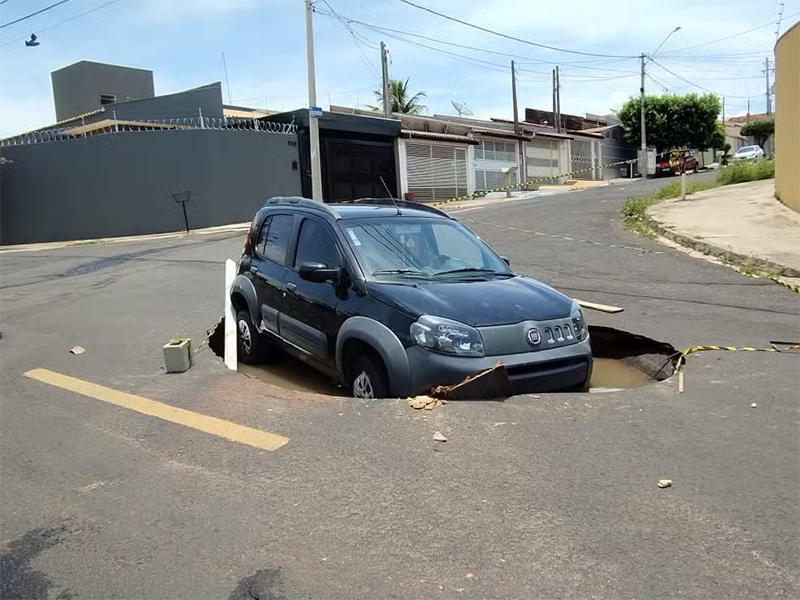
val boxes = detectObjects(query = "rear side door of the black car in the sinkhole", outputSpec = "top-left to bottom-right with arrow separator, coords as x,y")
250,213 -> 295,335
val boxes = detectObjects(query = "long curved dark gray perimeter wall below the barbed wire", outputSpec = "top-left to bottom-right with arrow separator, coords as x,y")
0,129 -> 301,245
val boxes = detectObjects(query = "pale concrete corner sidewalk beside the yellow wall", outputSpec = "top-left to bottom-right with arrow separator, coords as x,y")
647,179 -> 800,277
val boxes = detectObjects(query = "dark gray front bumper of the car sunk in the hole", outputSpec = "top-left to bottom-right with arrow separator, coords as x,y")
406,337 -> 592,395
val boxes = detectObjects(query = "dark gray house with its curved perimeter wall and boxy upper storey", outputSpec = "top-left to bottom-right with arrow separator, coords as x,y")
0,61 -> 301,244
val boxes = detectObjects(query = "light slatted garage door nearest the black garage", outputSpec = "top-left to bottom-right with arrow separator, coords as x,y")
406,141 -> 467,202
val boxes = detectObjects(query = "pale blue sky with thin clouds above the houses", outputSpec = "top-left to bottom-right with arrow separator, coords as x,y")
0,0 -> 800,136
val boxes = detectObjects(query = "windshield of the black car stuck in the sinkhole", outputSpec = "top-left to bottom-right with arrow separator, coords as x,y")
341,216 -> 513,279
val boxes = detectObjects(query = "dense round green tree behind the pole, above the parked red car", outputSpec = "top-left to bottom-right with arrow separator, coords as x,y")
618,94 -> 721,152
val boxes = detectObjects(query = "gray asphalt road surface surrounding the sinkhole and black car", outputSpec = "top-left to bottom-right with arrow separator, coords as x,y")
0,175 -> 800,600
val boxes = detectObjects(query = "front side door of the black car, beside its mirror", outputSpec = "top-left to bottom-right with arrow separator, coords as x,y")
280,216 -> 343,368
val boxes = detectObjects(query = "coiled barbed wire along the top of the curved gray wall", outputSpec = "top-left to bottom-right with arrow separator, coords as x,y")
0,117 -> 297,147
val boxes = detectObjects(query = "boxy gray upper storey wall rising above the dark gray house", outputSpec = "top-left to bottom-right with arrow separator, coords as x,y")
50,60 -> 155,121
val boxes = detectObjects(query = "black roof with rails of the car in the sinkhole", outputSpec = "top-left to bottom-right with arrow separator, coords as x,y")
263,196 -> 451,220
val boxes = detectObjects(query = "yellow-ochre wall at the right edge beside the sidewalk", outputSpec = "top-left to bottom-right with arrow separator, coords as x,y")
775,23 -> 800,212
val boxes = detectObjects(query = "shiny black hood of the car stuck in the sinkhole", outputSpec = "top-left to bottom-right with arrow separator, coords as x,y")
367,277 -> 572,327
